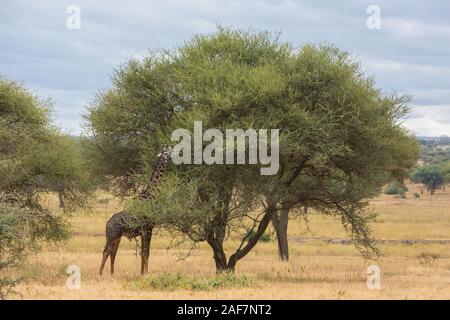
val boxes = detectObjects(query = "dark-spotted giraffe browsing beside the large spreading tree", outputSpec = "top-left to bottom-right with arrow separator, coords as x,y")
99,146 -> 172,275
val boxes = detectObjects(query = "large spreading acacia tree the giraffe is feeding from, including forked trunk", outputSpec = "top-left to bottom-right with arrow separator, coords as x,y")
88,28 -> 417,272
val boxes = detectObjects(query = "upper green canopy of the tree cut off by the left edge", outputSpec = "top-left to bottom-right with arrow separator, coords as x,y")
0,79 -> 95,210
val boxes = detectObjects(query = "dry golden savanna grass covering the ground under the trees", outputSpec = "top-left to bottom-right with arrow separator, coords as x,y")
7,185 -> 450,299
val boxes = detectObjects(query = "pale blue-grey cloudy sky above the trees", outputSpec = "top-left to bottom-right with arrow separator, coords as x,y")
0,0 -> 450,136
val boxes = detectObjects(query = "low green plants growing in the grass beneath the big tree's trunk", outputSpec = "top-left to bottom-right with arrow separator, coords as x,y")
131,272 -> 253,291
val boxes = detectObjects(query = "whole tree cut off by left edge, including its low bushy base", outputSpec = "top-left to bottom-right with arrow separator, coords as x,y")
0,79 -> 90,298
